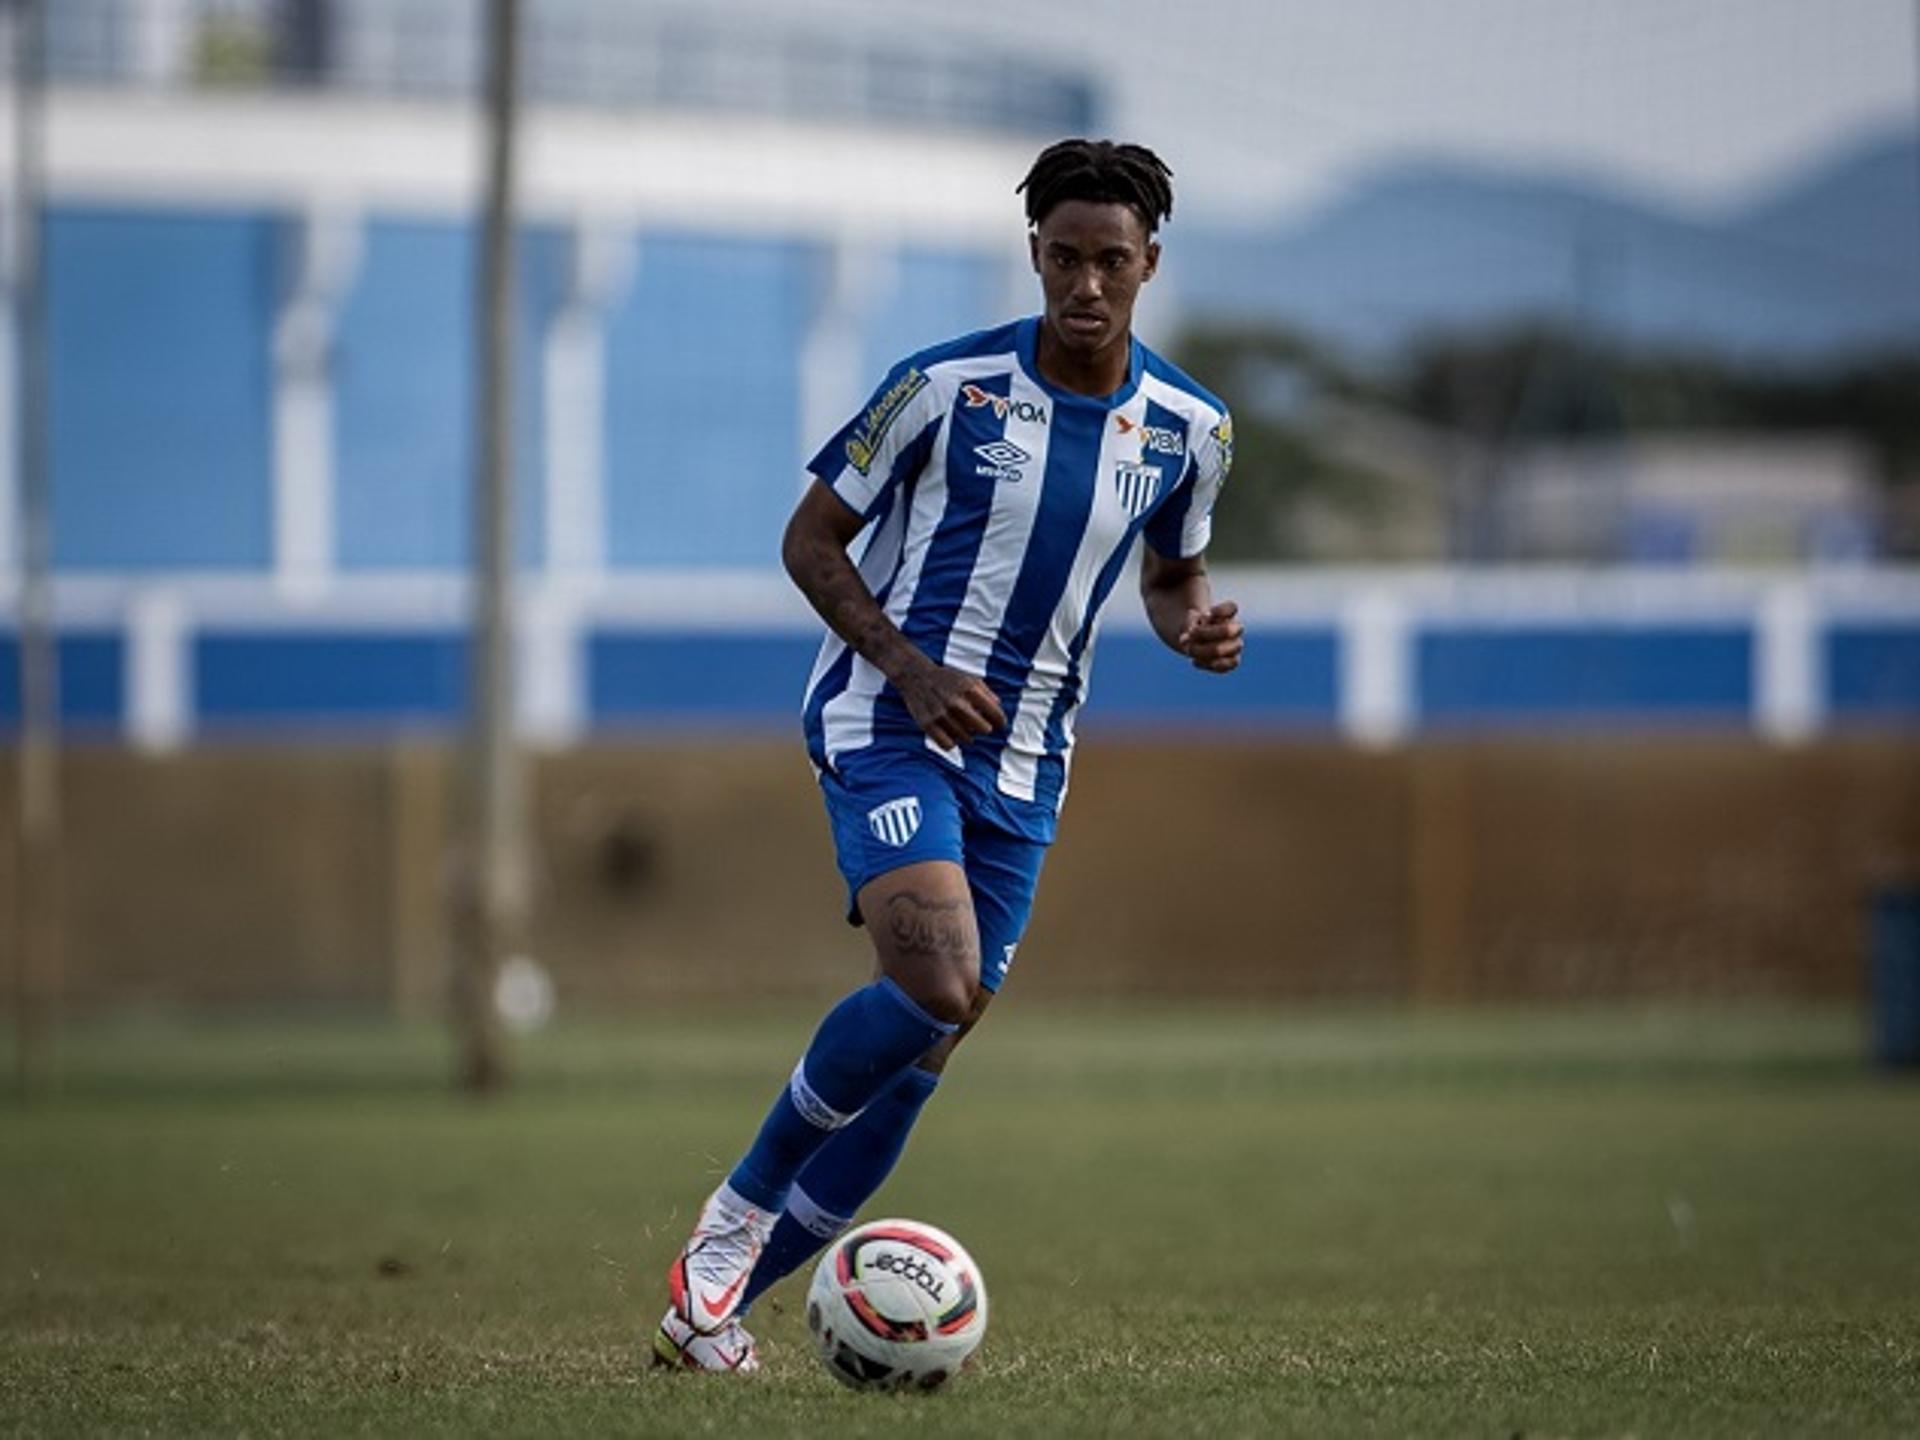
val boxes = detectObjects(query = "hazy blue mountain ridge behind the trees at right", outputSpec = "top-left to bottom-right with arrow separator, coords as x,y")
1167,138 -> 1920,361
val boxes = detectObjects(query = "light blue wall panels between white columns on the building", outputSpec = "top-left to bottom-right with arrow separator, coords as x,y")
46,205 -> 1002,574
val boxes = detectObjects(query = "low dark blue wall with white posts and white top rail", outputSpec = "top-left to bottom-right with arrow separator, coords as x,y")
11,568 -> 1920,751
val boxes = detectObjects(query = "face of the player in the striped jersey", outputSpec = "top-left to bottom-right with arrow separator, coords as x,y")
1029,200 -> 1160,357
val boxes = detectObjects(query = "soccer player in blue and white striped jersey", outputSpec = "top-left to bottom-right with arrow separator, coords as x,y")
655,140 -> 1242,1371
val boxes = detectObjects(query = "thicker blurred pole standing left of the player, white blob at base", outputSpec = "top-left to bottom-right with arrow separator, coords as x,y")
455,0 -> 526,1092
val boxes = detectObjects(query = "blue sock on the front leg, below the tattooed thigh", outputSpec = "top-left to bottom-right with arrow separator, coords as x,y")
728,979 -> 956,1212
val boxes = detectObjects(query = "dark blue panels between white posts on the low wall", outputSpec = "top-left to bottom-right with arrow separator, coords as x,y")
0,614 -> 1920,739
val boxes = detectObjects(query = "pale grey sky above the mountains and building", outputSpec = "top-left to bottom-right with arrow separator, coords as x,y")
703,0 -> 1920,219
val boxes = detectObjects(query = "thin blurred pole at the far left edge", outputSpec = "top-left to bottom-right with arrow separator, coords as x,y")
13,0 -> 61,1092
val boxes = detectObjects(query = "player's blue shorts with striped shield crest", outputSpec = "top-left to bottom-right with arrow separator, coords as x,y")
820,747 -> 1046,991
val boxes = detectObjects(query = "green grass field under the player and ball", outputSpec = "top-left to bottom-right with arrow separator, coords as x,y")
0,1006 -> 1920,1436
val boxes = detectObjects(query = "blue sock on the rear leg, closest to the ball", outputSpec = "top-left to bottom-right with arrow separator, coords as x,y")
739,1066 -> 941,1313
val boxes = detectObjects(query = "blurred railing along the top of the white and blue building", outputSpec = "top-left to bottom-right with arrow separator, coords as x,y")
48,0 -> 1098,134
